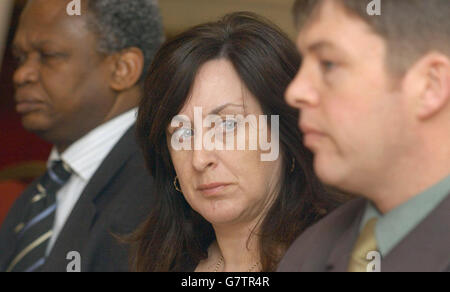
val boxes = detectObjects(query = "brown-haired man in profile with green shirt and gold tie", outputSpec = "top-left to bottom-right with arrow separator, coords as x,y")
279,0 -> 450,271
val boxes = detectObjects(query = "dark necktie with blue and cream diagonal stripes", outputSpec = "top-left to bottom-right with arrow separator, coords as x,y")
6,161 -> 72,272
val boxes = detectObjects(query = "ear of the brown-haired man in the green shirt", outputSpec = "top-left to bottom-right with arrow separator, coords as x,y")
411,52 -> 450,120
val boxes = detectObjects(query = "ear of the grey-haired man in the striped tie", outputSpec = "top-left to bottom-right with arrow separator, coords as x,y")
110,47 -> 144,91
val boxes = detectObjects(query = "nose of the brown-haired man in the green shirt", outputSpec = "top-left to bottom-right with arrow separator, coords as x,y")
285,65 -> 319,109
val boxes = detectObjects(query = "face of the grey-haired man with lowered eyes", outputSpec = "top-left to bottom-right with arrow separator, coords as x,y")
13,0 -> 112,146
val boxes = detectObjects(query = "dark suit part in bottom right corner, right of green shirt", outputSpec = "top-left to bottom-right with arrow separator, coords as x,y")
381,194 -> 450,272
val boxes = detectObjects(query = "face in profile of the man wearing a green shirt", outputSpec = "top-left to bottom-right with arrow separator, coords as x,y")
286,1 -> 411,194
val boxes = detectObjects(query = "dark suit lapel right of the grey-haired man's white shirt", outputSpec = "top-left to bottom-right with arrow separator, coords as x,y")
43,126 -> 138,271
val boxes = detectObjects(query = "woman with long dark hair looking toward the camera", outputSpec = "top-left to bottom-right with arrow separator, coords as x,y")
131,12 -> 337,272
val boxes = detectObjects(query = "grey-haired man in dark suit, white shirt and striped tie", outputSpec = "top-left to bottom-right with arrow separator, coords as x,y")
0,0 -> 163,272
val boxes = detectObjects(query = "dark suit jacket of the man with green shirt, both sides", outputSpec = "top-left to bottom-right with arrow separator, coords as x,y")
278,195 -> 450,272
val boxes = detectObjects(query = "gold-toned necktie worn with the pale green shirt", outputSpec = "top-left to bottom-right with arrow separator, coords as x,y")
348,218 -> 378,272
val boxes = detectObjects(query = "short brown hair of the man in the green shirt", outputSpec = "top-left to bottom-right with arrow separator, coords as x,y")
294,0 -> 450,75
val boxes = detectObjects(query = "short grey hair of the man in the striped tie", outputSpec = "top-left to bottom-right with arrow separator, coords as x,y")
87,0 -> 164,81
